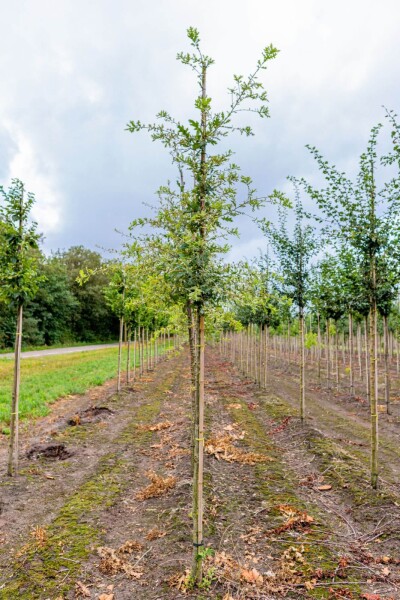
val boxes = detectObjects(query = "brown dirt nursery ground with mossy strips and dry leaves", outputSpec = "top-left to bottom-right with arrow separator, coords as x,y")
0,347 -> 400,600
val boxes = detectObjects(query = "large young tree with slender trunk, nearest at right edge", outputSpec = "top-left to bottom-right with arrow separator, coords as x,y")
302,112 -> 400,488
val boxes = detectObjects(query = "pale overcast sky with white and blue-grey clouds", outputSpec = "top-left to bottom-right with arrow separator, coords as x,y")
0,0 -> 400,259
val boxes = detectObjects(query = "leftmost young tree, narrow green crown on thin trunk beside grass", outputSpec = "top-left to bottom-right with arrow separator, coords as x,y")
0,179 -> 41,476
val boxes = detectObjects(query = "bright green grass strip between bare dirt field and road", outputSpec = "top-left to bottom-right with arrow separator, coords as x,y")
0,348 -> 173,431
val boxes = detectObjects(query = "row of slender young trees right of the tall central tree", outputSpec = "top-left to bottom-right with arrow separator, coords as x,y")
223,111 -> 400,488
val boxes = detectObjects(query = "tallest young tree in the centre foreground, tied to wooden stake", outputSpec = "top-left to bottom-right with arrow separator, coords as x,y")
127,27 -> 278,582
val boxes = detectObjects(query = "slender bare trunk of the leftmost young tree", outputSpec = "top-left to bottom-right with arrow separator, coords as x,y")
7,304 -> 23,477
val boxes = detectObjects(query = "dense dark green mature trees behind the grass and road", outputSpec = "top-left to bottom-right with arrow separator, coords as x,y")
0,246 -> 118,348
